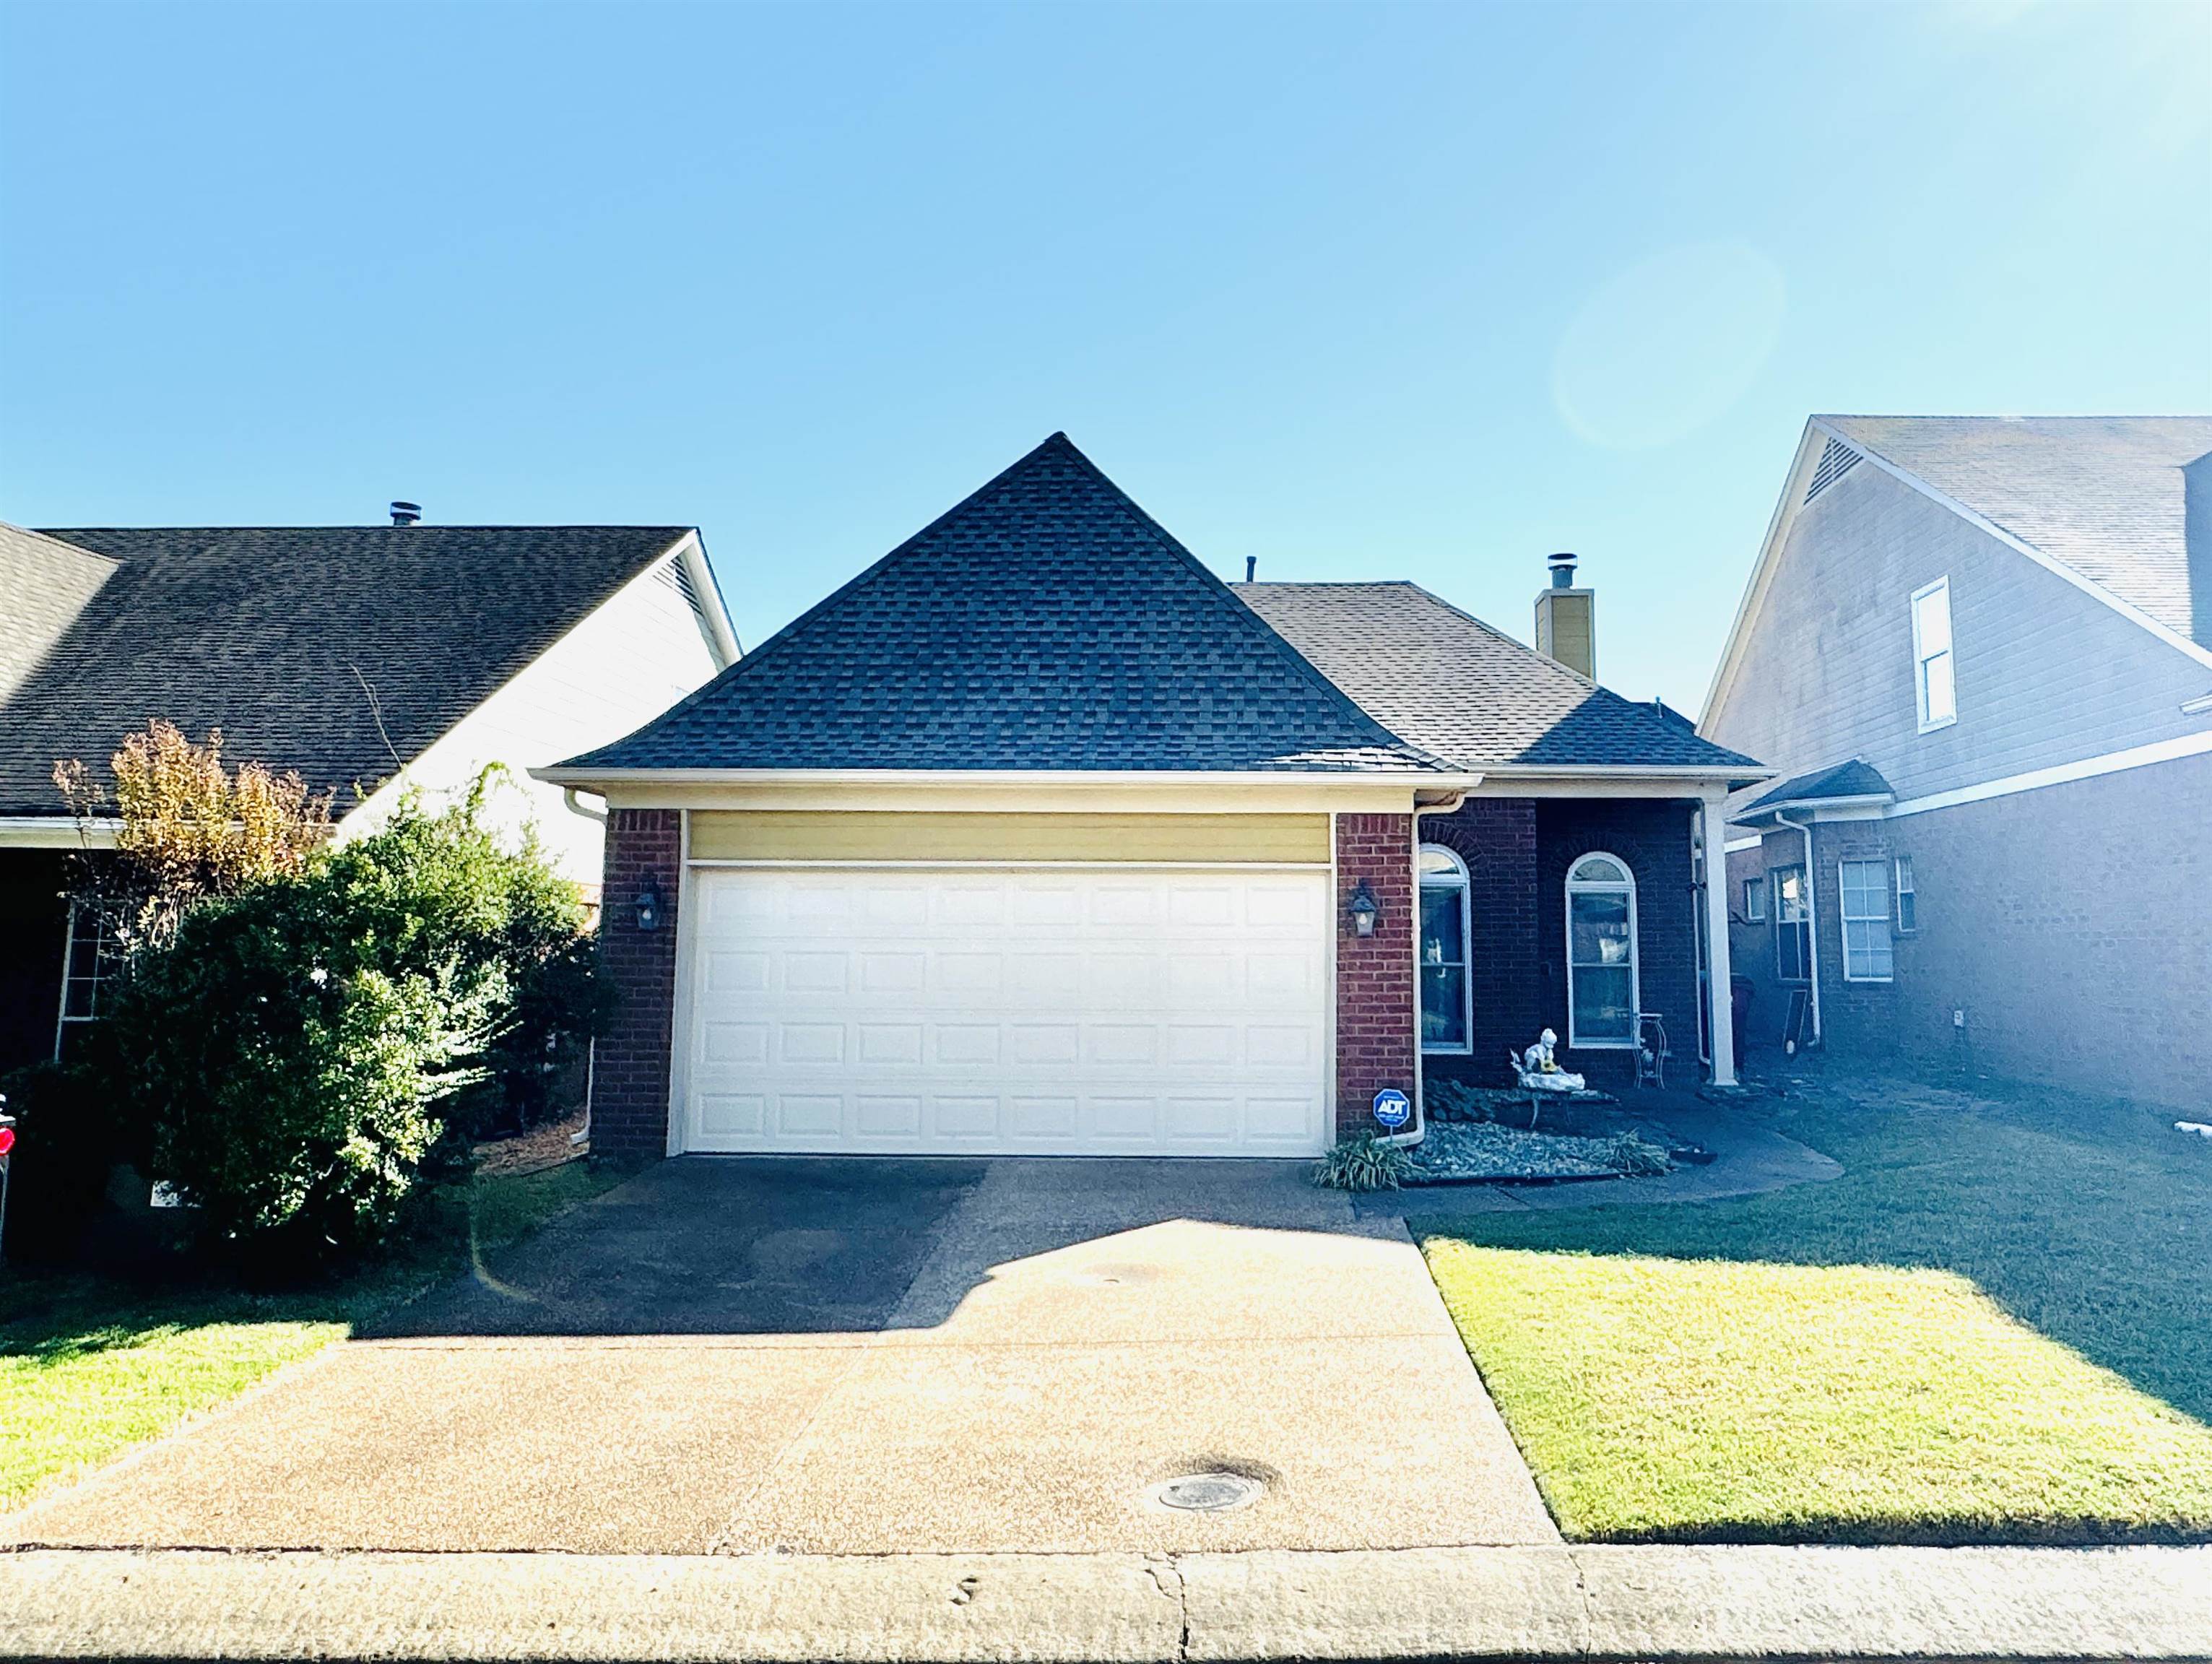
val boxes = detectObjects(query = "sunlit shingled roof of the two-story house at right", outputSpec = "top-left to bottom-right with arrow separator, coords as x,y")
1816,416 -> 2212,646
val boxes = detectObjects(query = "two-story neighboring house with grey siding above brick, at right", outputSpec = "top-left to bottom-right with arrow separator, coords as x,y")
1699,416 -> 2212,1106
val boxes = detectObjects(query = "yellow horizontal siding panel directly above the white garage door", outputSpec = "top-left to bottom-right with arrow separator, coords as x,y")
690,810 -> 1330,865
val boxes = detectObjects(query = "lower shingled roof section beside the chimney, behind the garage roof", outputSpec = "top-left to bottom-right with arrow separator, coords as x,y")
1236,582 -> 1761,779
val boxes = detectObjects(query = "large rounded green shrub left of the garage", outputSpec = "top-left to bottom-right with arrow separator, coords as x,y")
91,792 -> 597,1263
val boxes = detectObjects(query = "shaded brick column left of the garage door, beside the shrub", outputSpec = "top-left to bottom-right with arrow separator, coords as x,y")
591,810 -> 683,1162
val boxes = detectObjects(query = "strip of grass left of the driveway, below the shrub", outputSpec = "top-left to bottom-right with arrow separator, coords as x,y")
0,1162 -> 620,1507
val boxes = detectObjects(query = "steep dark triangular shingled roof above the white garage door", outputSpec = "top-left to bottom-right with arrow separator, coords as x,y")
566,434 -> 1438,772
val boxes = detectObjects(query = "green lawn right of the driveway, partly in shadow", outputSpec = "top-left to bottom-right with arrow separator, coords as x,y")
1413,1084 -> 2212,1542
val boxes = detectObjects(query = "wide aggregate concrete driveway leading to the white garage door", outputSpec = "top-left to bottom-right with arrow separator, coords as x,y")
0,1157 -> 1557,1554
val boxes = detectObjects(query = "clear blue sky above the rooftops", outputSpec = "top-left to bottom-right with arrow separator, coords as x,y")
0,4 -> 2212,710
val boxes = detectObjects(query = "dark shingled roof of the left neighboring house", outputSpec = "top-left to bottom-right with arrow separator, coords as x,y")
0,526 -> 690,817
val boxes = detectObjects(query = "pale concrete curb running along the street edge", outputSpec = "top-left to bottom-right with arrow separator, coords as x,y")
0,1547 -> 2212,1664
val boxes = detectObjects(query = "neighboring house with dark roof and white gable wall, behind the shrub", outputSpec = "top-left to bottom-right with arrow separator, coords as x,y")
0,505 -> 739,1073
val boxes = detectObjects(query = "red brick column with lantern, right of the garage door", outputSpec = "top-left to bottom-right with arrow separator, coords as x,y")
1336,814 -> 1418,1138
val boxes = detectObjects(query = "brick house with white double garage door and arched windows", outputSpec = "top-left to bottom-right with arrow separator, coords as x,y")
539,434 -> 1765,1155
